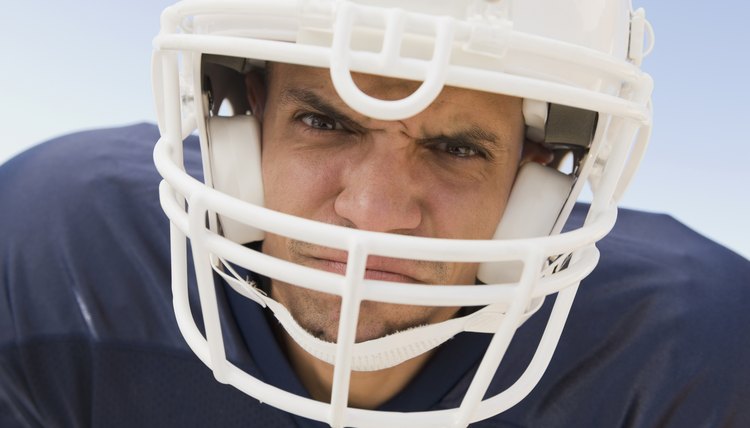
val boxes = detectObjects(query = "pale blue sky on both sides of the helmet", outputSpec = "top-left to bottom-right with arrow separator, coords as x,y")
0,0 -> 750,258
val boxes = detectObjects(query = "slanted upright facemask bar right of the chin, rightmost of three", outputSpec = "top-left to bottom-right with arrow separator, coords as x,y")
453,247 -> 545,427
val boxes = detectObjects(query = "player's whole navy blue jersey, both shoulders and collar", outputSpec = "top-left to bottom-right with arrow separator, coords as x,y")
0,124 -> 750,427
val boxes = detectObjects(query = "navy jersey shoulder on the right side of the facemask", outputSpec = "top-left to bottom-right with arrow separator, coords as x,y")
536,207 -> 750,427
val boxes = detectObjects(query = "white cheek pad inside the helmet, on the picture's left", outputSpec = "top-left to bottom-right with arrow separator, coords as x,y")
206,115 -> 264,244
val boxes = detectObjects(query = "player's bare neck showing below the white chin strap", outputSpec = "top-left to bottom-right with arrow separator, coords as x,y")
278,329 -> 432,409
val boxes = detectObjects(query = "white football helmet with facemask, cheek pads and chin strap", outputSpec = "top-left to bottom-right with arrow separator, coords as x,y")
153,0 -> 653,427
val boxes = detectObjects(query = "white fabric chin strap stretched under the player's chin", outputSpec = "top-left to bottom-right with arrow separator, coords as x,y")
211,260 -> 544,371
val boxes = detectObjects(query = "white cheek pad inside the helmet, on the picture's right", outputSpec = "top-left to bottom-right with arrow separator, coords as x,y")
477,162 -> 574,284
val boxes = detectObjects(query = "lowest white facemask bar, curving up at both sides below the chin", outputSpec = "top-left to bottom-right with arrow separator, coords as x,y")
160,192 -> 592,428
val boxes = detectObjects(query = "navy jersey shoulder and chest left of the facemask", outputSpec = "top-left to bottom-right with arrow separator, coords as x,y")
0,124 -> 304,427
